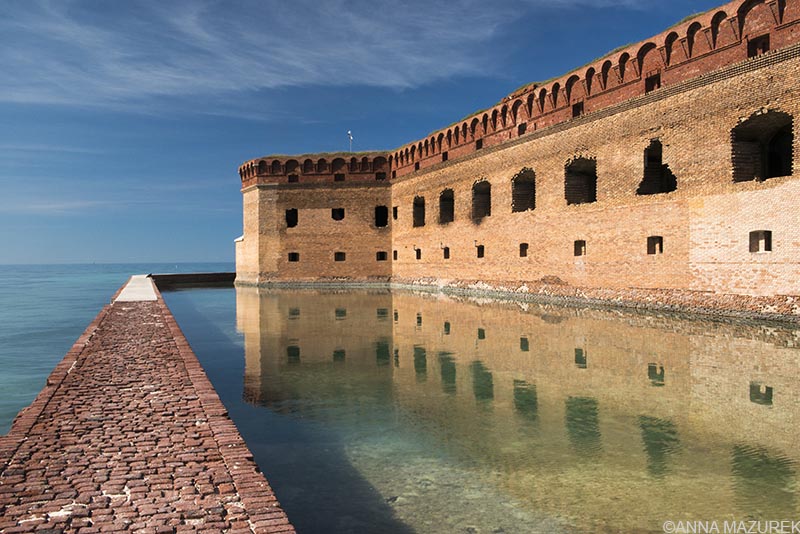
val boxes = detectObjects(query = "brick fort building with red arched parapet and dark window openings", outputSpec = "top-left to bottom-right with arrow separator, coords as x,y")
236,0 -> 800,315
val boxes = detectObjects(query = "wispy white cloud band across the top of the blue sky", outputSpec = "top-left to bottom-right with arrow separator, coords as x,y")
0,0 -> 649,109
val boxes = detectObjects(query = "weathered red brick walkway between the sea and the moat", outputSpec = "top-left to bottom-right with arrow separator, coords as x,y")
0,282 -> 294,533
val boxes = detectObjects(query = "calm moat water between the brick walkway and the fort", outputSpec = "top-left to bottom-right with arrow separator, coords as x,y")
165,289 -> 800,534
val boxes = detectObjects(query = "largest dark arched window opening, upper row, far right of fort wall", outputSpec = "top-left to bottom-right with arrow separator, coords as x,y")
731,111 -> 794,182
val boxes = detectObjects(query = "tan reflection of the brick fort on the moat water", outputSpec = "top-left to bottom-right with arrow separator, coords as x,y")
237,288 -> 800,526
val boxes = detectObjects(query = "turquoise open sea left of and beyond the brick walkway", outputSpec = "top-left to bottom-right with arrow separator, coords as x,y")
0,262 -> 234,435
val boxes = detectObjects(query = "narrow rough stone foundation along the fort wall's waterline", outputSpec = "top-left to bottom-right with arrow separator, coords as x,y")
236,278 -> 800,324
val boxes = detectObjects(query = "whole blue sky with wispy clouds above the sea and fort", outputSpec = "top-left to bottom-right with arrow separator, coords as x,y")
0,0 -> 720,263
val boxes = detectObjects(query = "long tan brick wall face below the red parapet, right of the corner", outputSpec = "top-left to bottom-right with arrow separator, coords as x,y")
392,49 -> 800,295
